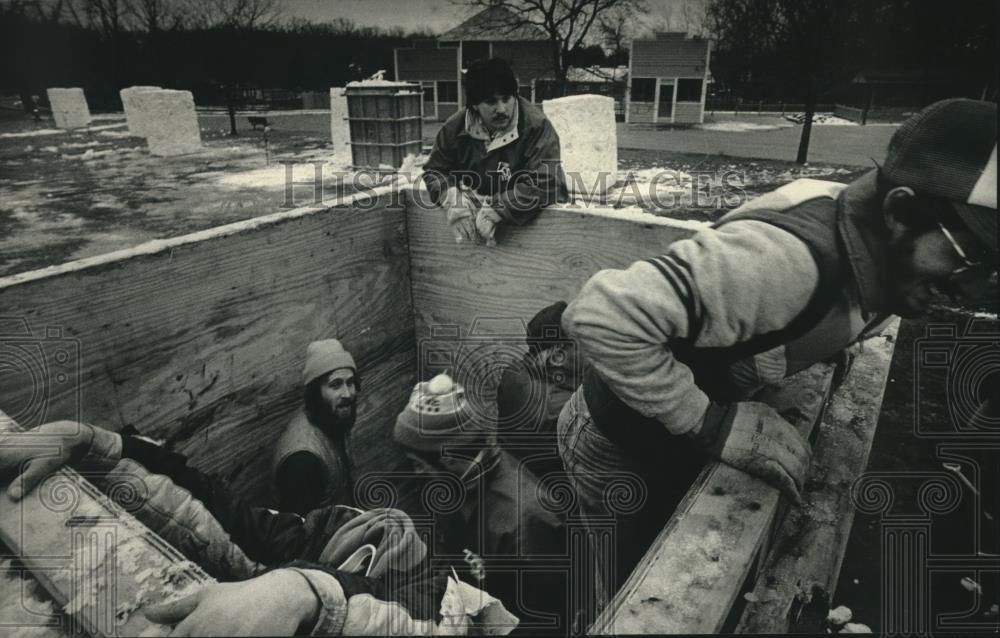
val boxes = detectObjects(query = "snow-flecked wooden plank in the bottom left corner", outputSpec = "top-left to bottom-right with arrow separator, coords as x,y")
0,412 -> 215,636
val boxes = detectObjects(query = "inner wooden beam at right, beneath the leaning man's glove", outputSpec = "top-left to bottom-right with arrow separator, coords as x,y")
590,364 -> 832,635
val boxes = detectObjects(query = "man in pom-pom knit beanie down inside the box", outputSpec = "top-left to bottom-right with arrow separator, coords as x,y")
393,374 -> 568,635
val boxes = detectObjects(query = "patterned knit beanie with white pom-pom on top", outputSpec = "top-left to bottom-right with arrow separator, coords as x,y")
393,374 -> 486,454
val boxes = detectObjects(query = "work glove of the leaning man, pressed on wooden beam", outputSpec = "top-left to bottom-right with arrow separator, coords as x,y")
694,401 -> 810,504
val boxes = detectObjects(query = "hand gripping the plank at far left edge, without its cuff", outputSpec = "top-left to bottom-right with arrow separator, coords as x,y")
0,421 -> 94,501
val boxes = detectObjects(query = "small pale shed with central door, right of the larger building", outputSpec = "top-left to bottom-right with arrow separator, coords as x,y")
625,32 -> 711,124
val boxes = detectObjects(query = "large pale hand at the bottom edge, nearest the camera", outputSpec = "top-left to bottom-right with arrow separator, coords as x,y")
143,569 -> 319,636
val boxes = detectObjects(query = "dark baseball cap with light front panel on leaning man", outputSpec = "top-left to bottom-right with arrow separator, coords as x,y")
882,98 -> 997,252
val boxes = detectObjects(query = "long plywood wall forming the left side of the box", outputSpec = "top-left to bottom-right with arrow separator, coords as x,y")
0,189 -> 415,499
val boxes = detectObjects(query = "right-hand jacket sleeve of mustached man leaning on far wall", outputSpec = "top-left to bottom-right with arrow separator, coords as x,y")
494,120 -> 567,225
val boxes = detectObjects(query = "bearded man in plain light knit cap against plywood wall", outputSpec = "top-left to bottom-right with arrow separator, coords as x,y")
271,339 -> 360,514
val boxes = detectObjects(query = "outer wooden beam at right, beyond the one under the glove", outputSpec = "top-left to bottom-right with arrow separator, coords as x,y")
736,319 -> 899,635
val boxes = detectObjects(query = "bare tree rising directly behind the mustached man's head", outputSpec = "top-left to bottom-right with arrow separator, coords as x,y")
461,0 -> 646,83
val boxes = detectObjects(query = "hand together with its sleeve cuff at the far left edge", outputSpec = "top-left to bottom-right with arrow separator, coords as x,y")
0,421 -> 121,501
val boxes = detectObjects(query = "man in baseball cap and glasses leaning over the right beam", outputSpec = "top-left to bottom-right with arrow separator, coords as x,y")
558,99 -> 997,608
